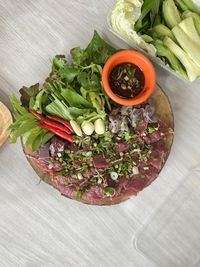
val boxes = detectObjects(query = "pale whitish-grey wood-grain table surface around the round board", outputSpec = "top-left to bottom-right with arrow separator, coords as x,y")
0,0 -> 200,267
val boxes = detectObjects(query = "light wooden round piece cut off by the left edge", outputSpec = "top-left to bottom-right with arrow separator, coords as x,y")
0,102 -> 13,147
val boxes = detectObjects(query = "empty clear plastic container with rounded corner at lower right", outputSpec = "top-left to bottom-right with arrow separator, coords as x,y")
134,170 -> 200,267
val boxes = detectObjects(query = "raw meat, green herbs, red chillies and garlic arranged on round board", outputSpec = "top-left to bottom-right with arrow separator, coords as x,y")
11,32 -> 173,205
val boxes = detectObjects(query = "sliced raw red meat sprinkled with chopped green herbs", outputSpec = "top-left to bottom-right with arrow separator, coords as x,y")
25,92 -> 173,205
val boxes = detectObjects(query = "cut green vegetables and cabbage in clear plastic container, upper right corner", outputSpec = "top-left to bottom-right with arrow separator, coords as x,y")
111,0 -> 200,81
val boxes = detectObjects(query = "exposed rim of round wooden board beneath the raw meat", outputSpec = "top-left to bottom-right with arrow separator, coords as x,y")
22,85 -> 174,205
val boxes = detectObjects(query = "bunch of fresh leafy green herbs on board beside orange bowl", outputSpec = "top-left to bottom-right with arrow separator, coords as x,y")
11,31 -> 116,151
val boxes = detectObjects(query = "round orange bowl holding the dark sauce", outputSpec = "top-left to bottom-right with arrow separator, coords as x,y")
102,50 -> 156,106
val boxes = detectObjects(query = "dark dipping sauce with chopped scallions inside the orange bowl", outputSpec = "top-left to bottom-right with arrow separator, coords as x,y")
109,62 -> 145,99
